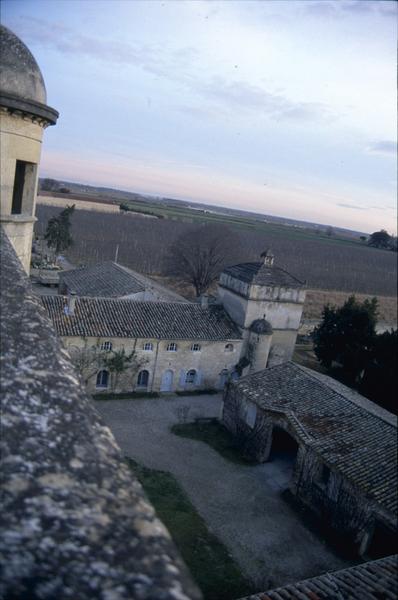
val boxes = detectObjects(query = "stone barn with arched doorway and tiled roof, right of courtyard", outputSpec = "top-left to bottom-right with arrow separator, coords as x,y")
222,362 -> 398,554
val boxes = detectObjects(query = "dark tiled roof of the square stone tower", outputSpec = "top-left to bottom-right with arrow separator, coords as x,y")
223,262 -> 304,288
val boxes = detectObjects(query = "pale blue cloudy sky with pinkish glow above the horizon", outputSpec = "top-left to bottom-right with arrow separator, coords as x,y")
2,0 -> 397,232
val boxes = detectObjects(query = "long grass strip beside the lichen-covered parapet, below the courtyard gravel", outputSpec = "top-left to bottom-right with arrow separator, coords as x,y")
127,458 -> 253,600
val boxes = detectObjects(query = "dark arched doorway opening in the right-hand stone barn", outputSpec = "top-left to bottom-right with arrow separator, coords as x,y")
268,425 -> 299,491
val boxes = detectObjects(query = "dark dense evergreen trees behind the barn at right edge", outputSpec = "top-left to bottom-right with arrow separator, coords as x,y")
313,296 -> 398,413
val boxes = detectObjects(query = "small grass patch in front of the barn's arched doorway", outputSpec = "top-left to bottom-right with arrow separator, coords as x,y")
171,419 -> 253,466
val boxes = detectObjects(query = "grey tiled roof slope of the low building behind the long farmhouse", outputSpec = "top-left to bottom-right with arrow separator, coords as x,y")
60,261 -> 145,298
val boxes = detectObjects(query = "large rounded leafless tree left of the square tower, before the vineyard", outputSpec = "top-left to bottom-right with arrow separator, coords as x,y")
167,223 -> 239,296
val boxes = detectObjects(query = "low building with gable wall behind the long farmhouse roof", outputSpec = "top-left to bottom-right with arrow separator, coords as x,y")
58,261 -> 187,302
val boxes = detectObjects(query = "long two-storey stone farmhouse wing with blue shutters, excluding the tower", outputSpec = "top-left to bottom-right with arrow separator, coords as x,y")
42,296 -> 242,392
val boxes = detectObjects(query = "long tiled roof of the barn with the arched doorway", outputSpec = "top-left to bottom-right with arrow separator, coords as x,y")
233,362 -> 397,514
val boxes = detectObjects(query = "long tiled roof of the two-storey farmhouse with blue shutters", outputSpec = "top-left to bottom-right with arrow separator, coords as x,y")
41,296 -> 241,341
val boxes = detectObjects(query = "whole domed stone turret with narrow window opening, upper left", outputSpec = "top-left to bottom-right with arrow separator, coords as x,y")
0,25 -> 58,272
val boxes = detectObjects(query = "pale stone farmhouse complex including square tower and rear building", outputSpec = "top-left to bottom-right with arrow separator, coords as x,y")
47,251 -> 305,392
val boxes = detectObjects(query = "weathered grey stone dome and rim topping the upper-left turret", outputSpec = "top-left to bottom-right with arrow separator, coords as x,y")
0,25 -> 58,124
